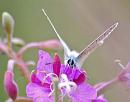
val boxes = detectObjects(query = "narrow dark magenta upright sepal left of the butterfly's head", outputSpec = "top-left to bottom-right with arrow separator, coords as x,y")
53,54 -> 61,77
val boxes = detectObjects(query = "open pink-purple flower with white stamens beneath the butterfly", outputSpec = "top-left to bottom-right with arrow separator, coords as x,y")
26,50 -> 106,102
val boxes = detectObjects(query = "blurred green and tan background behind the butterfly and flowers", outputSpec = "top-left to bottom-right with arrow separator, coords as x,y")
0,0 -> 130,102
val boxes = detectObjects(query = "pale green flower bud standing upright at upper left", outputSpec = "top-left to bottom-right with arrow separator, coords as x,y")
2,12 -> 14,36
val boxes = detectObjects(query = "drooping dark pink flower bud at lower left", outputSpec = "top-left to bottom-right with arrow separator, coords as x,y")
4,71 -> 18,100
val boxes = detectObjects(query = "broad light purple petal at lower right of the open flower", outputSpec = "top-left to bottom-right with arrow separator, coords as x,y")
70,83 -> 97,102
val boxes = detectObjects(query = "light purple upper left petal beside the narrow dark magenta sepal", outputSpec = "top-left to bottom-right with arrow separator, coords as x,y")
37,50 -> 53,73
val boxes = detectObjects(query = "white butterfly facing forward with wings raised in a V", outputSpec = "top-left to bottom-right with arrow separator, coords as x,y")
42,9 -> 118,68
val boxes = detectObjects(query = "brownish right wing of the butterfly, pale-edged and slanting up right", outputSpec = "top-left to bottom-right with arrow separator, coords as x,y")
76,23 -> 118,67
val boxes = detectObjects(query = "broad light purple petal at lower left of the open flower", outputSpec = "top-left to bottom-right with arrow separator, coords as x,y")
26,83 -> 54,102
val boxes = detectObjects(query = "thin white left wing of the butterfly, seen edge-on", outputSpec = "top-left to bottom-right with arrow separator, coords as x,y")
42,9 -> 70,60
